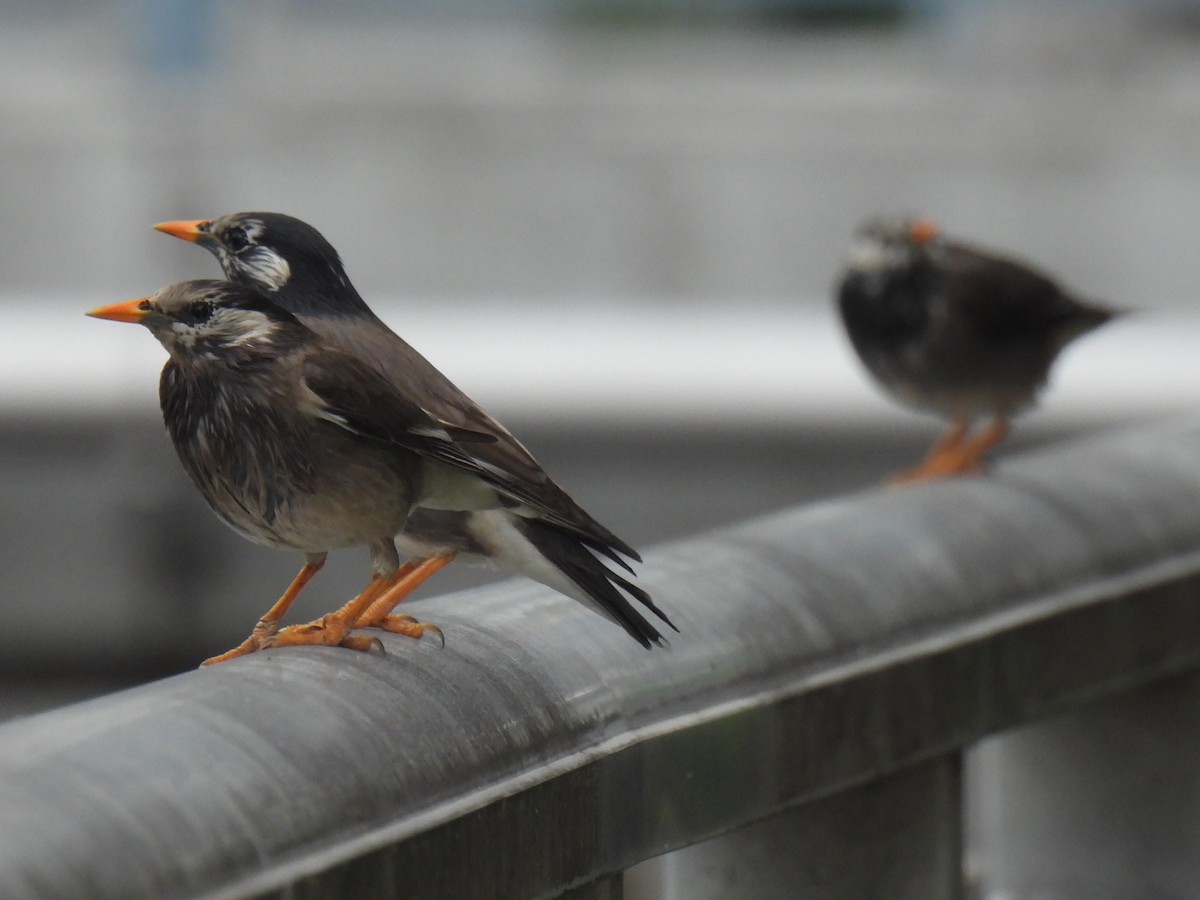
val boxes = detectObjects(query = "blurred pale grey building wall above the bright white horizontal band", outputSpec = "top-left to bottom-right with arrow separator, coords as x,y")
0,0 -> 1200,308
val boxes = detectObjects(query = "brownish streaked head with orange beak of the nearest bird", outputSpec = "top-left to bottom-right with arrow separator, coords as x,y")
88,281 -> 307,365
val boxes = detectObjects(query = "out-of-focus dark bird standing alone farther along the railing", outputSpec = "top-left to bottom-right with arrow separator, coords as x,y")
838,218 -> 1117,481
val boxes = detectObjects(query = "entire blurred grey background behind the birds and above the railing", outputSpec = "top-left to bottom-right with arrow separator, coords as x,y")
0,0 -> 1200,718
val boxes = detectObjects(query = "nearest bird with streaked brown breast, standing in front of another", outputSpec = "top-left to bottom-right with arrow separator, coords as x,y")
88,281 -> 470,661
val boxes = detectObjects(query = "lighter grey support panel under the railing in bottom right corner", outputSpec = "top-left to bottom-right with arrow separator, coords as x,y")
968,674 -> 1200,900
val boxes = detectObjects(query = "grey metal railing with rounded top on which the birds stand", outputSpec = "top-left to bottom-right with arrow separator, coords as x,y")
0,421 -> 1200,900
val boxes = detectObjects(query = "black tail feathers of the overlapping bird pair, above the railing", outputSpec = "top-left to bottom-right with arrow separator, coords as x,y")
520,518 -> 679,649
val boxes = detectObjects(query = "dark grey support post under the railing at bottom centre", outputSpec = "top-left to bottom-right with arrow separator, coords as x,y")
625,754 -> 962,900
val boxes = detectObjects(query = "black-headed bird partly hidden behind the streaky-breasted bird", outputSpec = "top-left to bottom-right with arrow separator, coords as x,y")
148,212 -> 678,648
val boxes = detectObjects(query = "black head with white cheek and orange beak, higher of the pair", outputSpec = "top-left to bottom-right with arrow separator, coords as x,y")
155,212 -> 348,294
